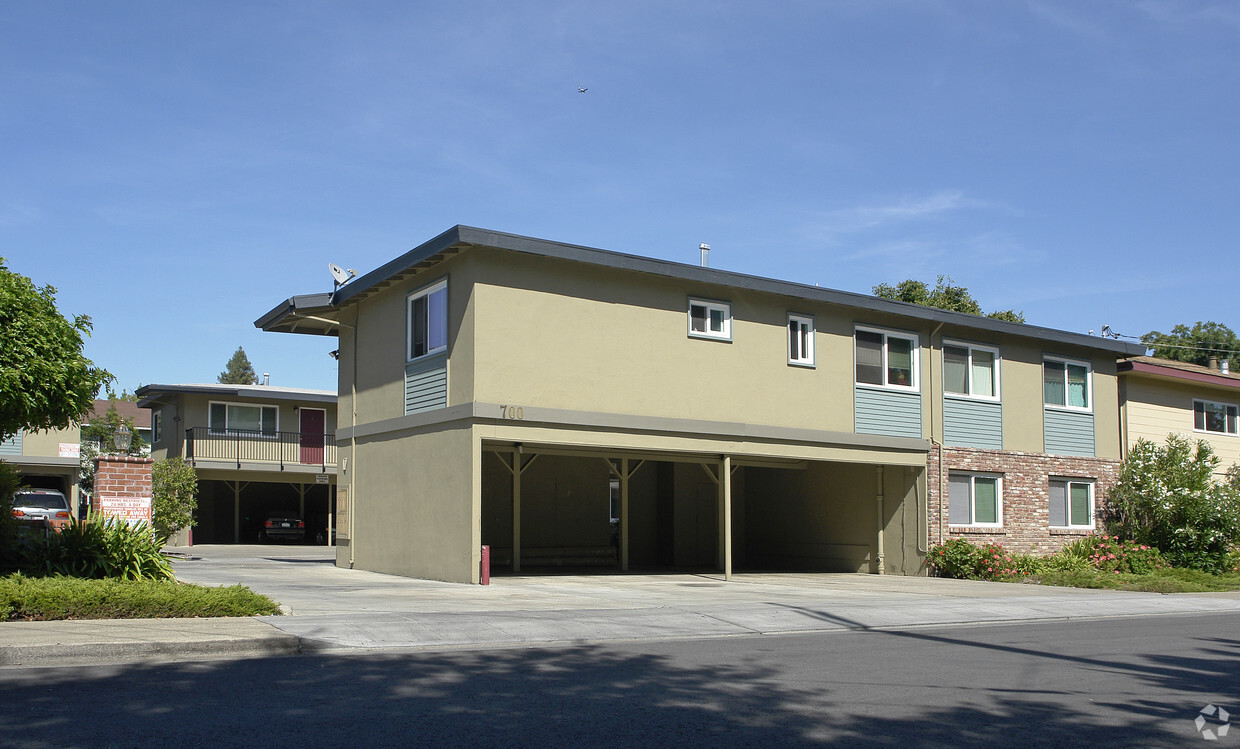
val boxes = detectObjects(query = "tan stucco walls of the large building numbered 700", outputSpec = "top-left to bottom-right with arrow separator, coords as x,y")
312,236 -> 1121,582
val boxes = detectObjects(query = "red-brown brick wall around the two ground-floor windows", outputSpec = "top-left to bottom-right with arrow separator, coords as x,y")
926,448 -> 1120,553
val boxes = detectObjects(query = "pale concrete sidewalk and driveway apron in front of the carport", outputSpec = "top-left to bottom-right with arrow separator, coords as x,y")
7,547 -> 1240,665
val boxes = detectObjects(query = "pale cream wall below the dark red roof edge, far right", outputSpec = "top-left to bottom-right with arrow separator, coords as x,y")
1122,375 -> 1240,475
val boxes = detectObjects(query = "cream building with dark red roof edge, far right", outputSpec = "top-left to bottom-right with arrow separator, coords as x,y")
1118,356 -> 1240,477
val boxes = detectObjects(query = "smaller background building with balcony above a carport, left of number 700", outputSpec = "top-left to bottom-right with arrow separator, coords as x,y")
138,384 -> 336,546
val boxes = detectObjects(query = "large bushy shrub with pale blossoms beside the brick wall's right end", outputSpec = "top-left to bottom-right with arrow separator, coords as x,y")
1106,434 -> 1240,573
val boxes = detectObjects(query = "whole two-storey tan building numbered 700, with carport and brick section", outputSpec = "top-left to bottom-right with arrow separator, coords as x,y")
255,227 -> 1142,582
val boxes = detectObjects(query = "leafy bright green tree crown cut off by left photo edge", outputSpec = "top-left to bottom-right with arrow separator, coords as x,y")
0,258 -> 112,439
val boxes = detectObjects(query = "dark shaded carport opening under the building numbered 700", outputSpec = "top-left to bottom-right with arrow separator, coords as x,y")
481,448 -> 916,575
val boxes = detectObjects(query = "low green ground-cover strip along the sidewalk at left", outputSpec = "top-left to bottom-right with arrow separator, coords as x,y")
0,574 -> 279,621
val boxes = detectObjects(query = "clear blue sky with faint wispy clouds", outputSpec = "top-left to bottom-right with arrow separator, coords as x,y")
0,0 -> 1240,391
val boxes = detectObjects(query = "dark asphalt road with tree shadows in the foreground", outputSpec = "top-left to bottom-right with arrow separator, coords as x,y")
0,614 -> 1240,748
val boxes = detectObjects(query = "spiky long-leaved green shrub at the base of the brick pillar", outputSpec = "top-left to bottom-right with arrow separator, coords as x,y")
29,516 -> 174,580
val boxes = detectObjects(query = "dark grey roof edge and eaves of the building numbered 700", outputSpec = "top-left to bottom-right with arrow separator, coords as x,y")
254,226 -> 1146,356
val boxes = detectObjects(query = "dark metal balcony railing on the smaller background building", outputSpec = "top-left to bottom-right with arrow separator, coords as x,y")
185,427 -> 336,472
